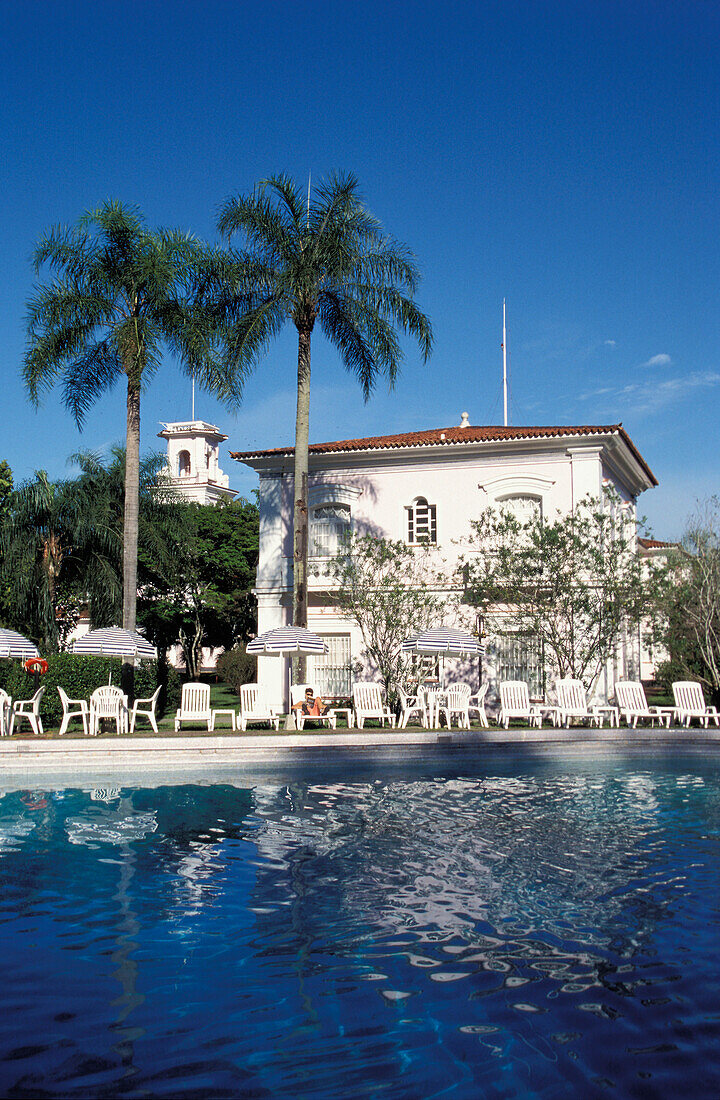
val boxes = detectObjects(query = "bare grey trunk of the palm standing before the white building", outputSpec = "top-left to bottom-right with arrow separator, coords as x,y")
292,330 -> 311,683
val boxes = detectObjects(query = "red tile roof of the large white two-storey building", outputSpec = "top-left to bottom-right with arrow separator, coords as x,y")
230,424 -> 657,485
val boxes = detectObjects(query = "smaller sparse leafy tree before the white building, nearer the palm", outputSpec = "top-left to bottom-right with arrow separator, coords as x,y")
328,535 -> 447,699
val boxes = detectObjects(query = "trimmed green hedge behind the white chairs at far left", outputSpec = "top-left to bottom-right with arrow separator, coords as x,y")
0,653 -> 181,729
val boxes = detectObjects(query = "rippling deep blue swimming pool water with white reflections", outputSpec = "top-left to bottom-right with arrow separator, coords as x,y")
0,758 -> 720,1100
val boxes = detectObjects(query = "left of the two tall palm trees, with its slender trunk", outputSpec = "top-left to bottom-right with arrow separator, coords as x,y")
23,200 -> 229,630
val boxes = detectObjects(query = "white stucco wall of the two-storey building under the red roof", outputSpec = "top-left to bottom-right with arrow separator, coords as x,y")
244,437 -> 646,707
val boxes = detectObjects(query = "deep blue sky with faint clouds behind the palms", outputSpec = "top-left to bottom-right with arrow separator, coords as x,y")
0,0 -> 720,538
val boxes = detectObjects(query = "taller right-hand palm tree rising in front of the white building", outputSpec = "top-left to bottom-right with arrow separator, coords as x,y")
219,175 -> 432,651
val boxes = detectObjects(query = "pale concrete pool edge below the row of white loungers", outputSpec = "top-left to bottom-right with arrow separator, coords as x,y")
0,728 -> 720,777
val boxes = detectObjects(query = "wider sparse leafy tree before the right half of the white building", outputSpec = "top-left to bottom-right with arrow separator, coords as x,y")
459,494 -> 652,690
